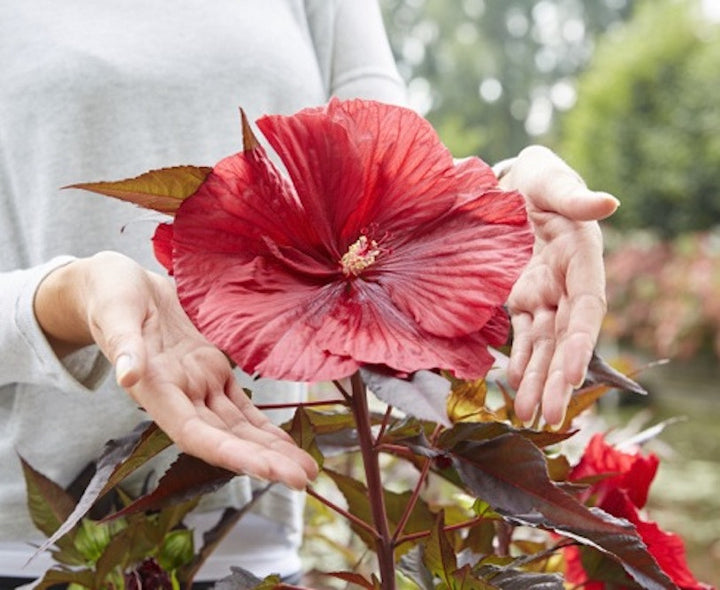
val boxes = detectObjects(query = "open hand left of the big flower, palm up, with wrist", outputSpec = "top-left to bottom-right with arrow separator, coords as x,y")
35,252 -> 317,489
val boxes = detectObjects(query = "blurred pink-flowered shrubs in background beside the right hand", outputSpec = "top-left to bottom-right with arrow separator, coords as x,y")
603,231 -> 720,359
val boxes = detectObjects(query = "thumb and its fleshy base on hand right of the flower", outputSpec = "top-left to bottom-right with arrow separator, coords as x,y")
504,146 -> 620,221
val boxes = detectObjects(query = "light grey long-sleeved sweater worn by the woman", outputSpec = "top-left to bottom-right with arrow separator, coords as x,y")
0,0 -> 404,575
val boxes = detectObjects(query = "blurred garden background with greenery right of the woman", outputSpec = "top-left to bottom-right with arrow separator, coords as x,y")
381,0 -> 720,586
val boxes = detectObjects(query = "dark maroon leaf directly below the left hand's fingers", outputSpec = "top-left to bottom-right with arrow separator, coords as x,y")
105,453 -> 237,520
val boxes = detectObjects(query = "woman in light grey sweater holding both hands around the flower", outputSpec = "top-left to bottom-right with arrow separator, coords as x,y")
0,0 -> 617,587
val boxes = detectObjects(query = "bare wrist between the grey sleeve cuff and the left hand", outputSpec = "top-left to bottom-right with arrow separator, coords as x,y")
33,259 -> 93,357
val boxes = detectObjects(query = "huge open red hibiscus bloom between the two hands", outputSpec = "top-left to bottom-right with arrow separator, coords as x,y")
155,100 -> 533,381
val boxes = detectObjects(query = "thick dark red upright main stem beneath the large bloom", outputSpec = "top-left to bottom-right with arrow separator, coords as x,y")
351,373 -> 395,590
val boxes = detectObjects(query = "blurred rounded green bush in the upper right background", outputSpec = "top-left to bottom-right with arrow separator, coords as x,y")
560,0 -> 720,238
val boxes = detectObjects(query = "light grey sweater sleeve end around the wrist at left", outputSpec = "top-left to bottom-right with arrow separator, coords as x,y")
0,256 -> 110,392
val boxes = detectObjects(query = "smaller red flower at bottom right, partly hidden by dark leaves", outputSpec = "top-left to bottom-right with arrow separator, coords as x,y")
564,435 -> 710,590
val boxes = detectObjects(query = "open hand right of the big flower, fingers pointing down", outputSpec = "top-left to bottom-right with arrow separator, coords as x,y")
501,146 -> 619,426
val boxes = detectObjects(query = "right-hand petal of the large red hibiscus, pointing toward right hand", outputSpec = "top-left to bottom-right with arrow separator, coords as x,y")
368,193 -> 533,337
